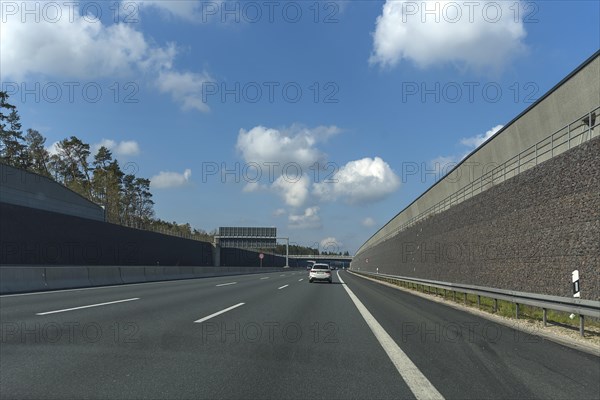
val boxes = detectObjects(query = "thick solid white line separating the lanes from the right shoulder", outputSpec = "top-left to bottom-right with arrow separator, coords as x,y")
337,272 -> 444,400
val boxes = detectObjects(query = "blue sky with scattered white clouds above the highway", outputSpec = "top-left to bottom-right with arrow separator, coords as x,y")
0,1 -> 600,253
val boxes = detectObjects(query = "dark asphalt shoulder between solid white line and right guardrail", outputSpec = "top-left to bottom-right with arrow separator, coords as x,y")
344,274 -> 600,399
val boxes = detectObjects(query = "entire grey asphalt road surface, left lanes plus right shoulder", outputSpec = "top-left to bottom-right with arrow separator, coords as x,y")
0,270 -> 600,399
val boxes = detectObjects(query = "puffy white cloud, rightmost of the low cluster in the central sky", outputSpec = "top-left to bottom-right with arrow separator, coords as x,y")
313,157 -> 400,204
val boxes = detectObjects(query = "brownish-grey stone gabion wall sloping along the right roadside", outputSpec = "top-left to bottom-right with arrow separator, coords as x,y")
352,138 -> 600,300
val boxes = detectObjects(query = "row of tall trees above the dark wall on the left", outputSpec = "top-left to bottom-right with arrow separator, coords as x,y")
0,91 -> 214,241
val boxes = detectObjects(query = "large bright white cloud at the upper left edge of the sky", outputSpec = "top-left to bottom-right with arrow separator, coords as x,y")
0,9 -> 175,80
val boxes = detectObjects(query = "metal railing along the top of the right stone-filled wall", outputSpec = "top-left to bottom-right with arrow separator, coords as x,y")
369,106 -> 600,247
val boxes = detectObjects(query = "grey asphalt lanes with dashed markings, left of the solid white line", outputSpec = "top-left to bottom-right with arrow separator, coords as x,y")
0,271 -> 412,399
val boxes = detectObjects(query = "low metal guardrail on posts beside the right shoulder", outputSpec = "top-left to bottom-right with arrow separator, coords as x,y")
351,270 -> 600,336
